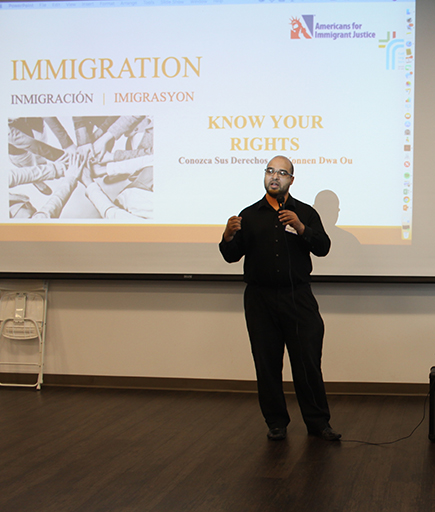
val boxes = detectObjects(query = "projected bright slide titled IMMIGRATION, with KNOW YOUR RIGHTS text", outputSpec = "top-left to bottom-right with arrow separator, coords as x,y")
0,2 -> 414,245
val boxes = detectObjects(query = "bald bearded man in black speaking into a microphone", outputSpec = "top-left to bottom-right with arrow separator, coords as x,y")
219,156 -> 341,441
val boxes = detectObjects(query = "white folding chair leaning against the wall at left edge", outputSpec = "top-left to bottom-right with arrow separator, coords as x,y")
0,281 -> 48,389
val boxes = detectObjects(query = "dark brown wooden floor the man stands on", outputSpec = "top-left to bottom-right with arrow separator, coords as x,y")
0,387 -> 435,512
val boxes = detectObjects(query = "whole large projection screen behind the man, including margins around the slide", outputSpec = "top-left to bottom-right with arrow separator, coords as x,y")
0,0 -> 435,276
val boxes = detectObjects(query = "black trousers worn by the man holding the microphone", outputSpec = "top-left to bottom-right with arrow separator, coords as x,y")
244,284 -> 330,431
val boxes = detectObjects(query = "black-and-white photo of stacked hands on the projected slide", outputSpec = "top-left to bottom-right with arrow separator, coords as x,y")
8,116 -> 154,223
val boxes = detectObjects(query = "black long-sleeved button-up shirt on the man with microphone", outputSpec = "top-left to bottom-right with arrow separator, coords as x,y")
219,196 -> 331,286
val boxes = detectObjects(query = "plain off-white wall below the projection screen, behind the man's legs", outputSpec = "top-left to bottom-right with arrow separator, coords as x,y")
33,280 -> 435,383
